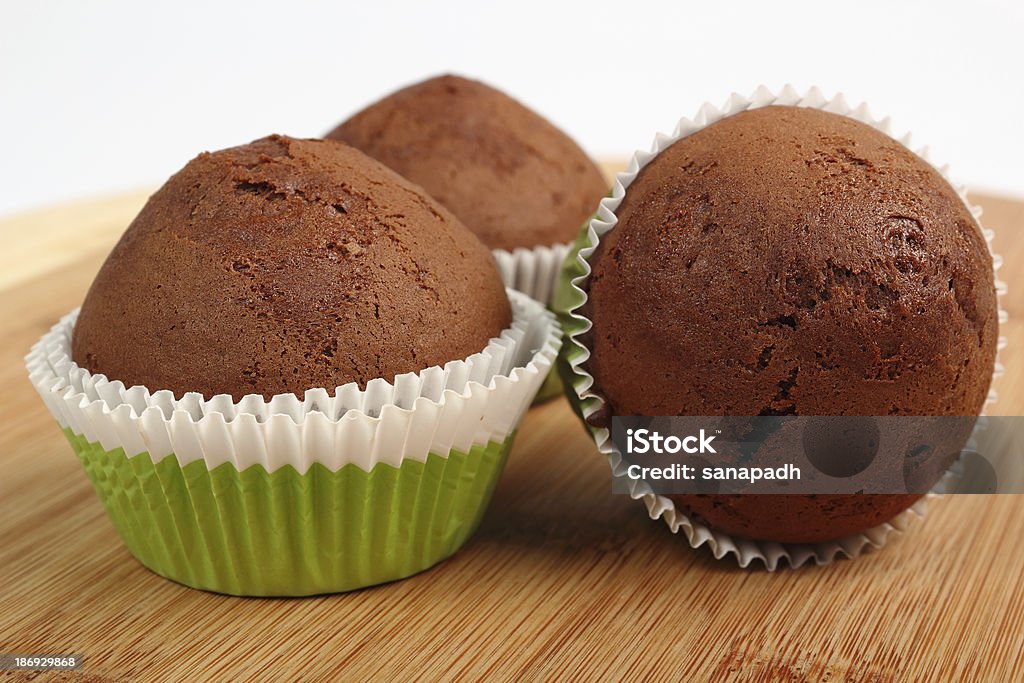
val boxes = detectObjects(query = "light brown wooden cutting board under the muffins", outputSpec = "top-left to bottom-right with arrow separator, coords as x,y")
0,184 -> 1024,681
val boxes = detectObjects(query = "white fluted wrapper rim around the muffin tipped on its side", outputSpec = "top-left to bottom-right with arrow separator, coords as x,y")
566,85 -> 1007,570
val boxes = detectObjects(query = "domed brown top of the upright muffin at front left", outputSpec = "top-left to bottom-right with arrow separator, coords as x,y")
72,135 -> 511,399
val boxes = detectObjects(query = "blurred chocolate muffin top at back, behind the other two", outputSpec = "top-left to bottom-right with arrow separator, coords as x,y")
328,76 -> 608,251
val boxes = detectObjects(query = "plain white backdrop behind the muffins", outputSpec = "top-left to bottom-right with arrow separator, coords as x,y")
0,0 -> 1024,215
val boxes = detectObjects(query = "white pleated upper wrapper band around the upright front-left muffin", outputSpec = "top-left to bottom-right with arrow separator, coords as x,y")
26,291 -> 561,473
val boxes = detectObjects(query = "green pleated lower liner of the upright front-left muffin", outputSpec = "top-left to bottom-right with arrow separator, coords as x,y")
63,429 -> 515,596
